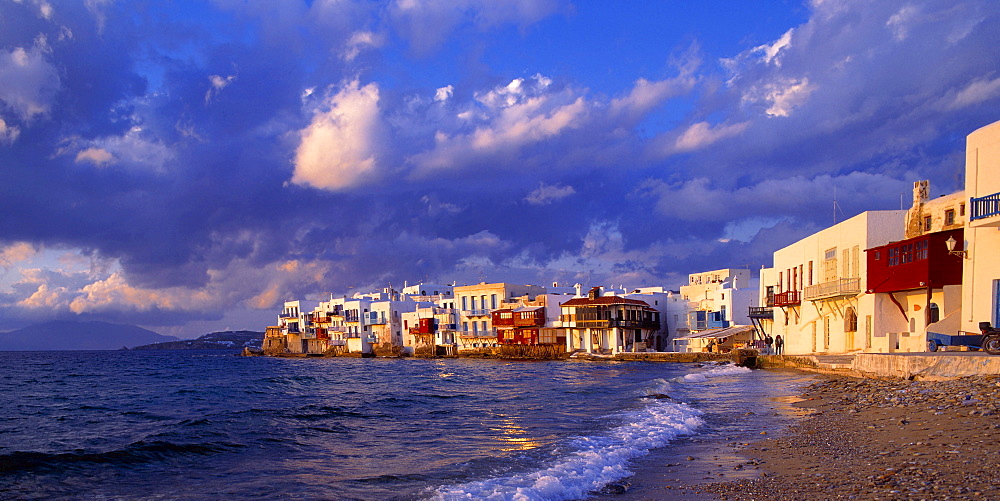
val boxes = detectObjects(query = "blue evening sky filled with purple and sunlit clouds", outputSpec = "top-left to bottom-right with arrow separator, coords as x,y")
0,0 -> 1000,338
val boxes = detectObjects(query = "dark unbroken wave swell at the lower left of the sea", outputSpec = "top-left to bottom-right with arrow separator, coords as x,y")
0,440 -> 244,474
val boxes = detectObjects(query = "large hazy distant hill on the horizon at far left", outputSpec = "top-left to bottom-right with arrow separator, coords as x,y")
0,321 -> 177,351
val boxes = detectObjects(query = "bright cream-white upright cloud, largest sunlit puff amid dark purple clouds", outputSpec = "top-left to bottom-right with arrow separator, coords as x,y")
292,80 -> 384,190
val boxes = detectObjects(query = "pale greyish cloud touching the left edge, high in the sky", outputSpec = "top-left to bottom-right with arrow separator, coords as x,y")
0,38 -> 60,121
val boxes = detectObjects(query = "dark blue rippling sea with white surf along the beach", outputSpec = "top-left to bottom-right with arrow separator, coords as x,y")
0,350 -> 811,501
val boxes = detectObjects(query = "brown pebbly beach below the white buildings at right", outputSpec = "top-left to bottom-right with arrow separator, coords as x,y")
688,376 -> 1000,500
